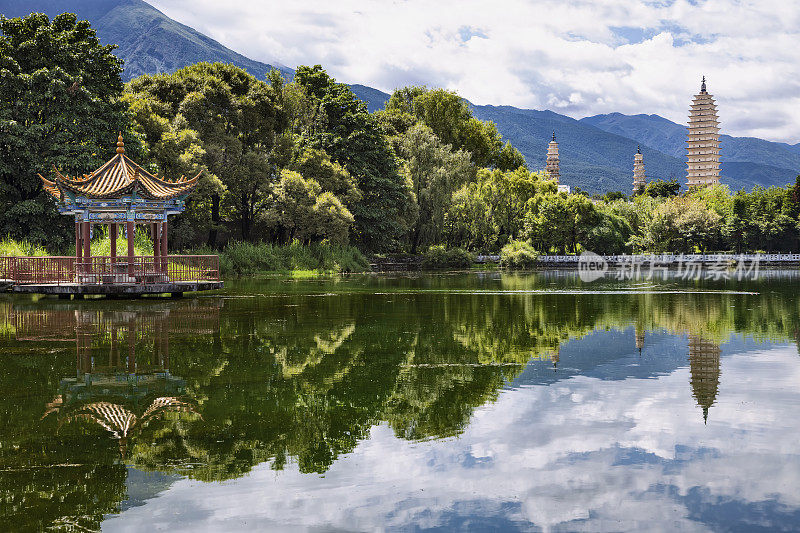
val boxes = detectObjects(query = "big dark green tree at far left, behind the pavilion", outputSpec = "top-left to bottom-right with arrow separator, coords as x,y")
0,13 -> 140,247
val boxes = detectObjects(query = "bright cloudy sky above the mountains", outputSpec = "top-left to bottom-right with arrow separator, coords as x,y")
150,0 -> 800,144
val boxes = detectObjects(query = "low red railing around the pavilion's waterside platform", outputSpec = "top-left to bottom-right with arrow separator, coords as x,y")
0,255 -> 219,285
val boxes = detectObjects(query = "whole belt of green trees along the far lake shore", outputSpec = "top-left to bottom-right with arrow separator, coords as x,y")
0,10 -> 800,254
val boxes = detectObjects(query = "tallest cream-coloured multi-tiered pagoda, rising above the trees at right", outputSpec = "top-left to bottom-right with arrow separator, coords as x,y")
686,76 -> 720,187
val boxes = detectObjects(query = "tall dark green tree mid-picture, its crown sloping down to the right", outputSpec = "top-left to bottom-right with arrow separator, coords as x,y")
295,65 -> 413,251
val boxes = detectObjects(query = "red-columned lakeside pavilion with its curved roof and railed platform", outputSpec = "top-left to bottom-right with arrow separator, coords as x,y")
0,134 -> 222,295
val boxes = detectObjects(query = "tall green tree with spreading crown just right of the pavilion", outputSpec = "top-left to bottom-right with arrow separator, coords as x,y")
126,63 -> 286,246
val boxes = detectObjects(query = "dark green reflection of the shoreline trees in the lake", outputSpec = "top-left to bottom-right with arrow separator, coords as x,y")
0,278 -> 799,527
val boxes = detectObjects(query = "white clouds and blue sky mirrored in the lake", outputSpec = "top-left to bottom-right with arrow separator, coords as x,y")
104,348 -> 800,531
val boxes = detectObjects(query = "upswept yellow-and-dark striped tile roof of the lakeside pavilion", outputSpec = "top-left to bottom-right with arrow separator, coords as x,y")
39,135 -> 202,204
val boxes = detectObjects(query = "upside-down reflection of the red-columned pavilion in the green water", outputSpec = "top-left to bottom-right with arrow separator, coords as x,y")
11,300 -> 219,458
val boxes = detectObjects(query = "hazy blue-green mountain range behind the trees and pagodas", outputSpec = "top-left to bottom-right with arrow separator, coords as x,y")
0,0 -> 800,193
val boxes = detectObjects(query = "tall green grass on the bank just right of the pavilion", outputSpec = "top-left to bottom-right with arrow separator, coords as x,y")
189,242 -> 369,277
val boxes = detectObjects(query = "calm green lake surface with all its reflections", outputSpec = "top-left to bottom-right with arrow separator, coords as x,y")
0,272 -> 800,531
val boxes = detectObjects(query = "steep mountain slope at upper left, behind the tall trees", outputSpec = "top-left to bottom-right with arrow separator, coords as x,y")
0,0 -> 292,81
